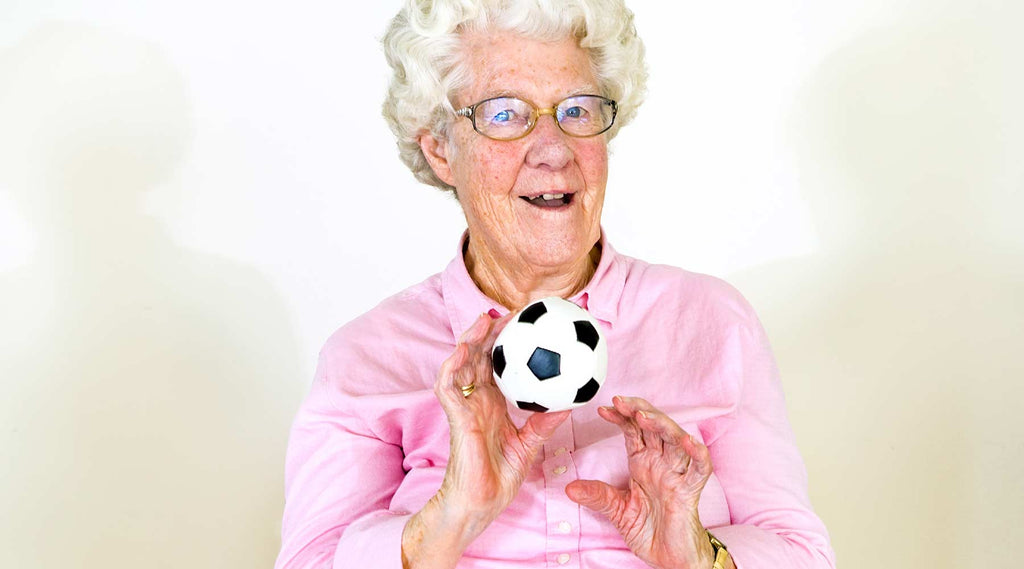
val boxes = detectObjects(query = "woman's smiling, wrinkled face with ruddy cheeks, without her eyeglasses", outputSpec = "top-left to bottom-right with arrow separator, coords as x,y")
435,33 -> 608,272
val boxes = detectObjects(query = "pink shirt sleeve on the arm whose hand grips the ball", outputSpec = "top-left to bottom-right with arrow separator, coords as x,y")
274,353 -> 411,569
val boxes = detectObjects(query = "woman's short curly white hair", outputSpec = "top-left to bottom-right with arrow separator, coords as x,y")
381,0 -> 647,190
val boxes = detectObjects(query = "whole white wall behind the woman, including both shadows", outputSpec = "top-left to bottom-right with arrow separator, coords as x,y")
0,0 -> 1024,568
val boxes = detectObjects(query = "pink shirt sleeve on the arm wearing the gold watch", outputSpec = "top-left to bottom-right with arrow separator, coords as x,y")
708,312 -> 836,569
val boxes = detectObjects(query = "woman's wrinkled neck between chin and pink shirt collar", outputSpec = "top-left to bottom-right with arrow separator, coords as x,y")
463,240 -> 601,311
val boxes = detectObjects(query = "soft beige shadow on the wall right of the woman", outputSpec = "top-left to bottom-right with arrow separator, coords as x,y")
731,3 -> 1024,569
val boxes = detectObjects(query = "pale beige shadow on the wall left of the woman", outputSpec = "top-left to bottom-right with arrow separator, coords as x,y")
0,23 -> 301,569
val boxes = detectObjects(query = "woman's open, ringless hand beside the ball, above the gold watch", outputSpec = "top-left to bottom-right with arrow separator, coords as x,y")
565,396 -> 715,569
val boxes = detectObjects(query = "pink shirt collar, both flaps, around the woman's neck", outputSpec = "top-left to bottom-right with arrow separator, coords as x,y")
441,229 -> 626,339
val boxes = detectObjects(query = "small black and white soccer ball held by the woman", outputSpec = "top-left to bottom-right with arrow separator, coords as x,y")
490,297 -> 608,412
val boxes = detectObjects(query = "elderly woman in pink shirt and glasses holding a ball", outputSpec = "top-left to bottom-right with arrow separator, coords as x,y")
278,0 -> 834,569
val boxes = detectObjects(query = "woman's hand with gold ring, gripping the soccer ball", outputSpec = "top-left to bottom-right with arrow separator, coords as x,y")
401,314 -> 569,569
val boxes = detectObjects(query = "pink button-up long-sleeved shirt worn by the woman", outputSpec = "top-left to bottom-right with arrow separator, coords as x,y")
276,234 -> 835,569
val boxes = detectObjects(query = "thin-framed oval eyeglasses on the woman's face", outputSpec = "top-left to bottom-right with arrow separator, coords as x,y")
455,95 -> 618,140
